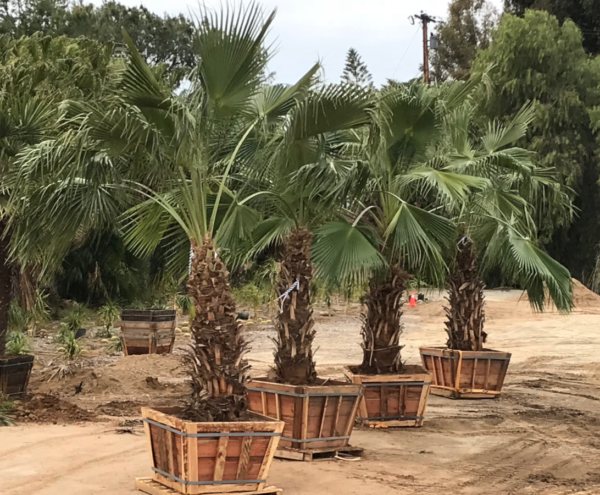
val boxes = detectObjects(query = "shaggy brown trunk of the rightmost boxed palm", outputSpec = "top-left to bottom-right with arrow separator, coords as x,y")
444,237 -> 486,351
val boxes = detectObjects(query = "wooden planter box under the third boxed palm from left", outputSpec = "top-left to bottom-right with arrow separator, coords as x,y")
344,365 -> 431,427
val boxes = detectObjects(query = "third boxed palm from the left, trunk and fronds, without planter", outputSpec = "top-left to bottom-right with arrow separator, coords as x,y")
313,78 -> 512,374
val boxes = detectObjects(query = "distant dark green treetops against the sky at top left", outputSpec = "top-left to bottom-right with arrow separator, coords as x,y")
0,0 -> 196,70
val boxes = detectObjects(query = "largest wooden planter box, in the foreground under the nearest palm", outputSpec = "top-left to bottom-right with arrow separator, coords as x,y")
142,407 -> 283,494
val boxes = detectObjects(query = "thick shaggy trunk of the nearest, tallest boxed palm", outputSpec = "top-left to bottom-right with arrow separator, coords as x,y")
186,234 -> 250,421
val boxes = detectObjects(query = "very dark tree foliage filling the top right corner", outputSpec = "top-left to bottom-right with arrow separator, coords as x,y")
504,0 -> 600,55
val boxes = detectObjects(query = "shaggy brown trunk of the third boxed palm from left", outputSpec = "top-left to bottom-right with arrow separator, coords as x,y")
361,266 -> 410,374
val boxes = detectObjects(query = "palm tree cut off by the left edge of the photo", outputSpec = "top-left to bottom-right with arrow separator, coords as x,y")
0,34 -> 114,355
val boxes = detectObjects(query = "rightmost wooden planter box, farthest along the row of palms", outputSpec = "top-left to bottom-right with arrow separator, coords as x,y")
420,347 -> 511,399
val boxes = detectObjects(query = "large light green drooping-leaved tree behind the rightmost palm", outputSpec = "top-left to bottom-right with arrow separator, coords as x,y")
473,10 -> 600,282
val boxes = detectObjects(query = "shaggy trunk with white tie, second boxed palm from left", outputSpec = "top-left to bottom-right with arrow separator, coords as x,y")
275,228 -> 317,385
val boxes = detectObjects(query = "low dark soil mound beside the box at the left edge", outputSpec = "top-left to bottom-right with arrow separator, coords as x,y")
15,394 -> 95,424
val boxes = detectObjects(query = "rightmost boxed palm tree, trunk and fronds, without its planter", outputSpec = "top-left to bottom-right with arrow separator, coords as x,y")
444,105 -> 573,351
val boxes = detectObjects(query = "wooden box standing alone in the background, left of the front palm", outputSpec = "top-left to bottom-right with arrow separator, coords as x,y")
121,309 -> 176,356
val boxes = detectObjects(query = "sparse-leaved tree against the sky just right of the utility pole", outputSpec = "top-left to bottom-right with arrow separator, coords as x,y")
431,0 -> 499,82
